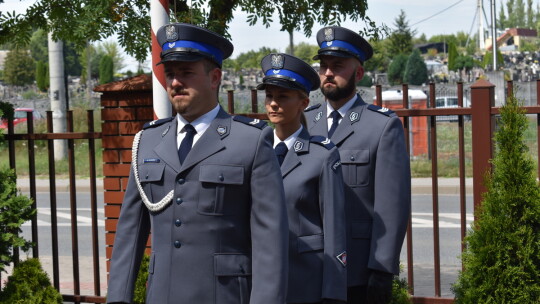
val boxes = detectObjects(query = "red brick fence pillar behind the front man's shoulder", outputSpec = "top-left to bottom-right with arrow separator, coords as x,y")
94,75 -> 153,271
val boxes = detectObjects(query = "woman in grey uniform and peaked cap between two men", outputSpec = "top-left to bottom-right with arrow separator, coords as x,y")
257,54 -> 347,303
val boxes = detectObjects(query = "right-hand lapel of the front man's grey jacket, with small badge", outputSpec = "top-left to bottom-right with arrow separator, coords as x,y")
180,108 -> 231,172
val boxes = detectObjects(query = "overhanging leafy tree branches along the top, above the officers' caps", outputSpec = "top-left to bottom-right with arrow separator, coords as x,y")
0,0 -> 385,61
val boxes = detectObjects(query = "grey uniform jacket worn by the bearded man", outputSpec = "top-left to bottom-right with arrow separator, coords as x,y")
305,96 -> 411,286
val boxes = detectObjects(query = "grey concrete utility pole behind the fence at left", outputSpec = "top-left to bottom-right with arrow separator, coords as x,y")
48,33 -> 67,160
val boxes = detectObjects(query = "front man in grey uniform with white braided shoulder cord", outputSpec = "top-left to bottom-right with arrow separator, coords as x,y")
107,23 -> 288,304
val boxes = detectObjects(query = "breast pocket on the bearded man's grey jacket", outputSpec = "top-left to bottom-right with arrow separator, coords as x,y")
339,149 -> 369,186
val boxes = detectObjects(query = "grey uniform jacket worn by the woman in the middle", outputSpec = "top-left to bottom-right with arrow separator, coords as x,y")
281,128 -> 347,303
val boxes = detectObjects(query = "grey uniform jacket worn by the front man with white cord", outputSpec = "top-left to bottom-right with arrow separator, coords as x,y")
107,109 -> 288,304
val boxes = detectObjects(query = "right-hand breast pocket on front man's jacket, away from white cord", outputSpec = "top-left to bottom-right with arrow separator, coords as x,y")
197,165 -> 244,215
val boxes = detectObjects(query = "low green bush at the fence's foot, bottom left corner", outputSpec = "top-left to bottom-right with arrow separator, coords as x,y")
0,259 -> 62,304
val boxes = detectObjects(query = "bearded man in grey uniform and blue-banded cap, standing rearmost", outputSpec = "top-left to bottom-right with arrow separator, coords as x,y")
305,27 -> 411,303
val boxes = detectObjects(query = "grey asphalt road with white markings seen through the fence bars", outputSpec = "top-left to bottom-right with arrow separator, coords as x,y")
17,192 -> 473,296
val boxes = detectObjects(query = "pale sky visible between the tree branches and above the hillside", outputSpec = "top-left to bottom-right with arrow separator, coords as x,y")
0,0 -> 488,71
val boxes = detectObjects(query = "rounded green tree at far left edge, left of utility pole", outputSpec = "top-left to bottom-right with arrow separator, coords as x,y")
4,49 -> 35,86
